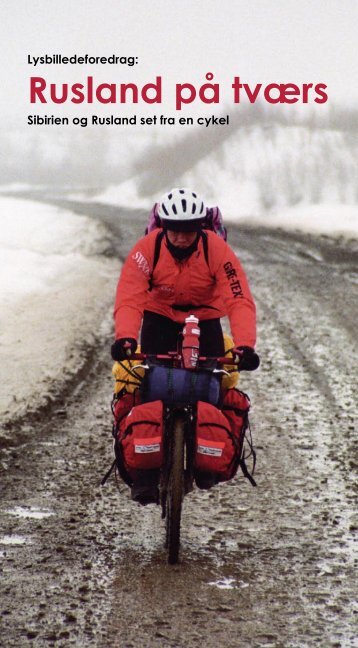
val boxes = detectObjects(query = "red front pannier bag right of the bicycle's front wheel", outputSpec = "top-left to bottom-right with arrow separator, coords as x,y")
194,401 -> 238,481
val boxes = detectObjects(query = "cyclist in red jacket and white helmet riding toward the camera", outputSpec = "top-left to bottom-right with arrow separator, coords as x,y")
111,188 -> 259,504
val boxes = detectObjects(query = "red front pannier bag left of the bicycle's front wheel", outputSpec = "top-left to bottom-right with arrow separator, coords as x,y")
117,401 -> 163,475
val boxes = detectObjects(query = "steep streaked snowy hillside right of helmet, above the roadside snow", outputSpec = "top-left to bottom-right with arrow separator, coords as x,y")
181,125 -> 358,214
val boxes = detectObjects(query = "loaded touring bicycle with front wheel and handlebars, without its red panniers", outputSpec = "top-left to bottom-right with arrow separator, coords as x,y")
111,352 -> 256,564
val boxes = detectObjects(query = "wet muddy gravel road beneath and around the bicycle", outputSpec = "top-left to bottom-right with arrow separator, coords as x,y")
0,201 -> 358,648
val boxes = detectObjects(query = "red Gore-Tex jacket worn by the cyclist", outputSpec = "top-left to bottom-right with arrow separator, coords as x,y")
114,230 -> 256,347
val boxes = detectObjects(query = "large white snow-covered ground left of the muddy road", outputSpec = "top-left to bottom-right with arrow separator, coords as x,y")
0,197 -> 118,432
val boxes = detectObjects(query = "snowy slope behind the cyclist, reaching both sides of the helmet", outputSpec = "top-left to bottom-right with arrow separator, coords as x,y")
86,125 -> 358,238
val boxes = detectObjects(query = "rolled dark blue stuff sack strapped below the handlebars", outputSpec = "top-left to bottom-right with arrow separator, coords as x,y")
141,366 -> 220,405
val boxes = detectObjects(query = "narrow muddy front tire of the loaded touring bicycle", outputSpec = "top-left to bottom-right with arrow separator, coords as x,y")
166,416 -> 184,565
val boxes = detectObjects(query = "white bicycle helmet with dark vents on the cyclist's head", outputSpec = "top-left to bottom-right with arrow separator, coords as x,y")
158,188 -> 206,232
